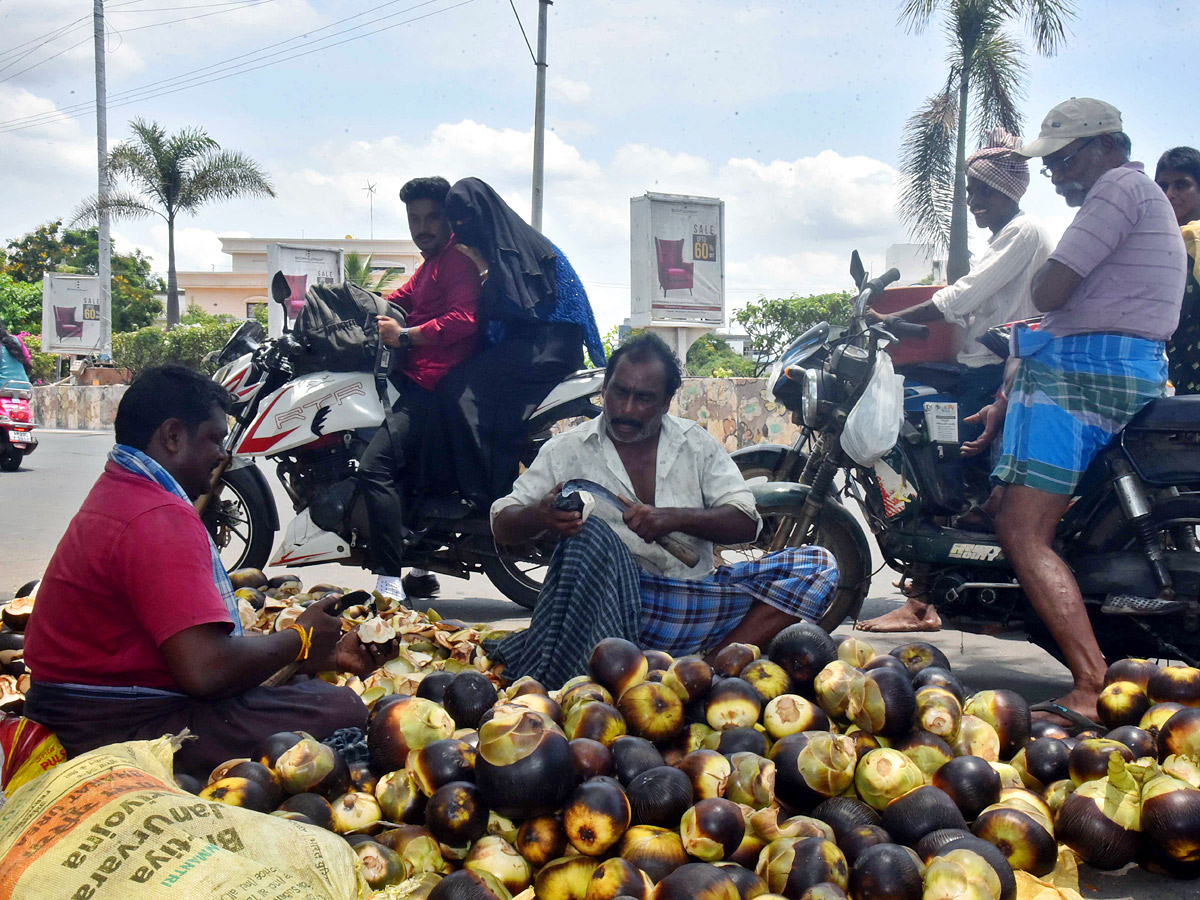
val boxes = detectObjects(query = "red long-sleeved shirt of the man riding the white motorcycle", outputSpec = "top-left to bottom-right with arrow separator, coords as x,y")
386,238 -> 479,390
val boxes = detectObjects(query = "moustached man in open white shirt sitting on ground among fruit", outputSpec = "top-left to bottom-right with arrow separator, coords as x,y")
488,334 -> 838,688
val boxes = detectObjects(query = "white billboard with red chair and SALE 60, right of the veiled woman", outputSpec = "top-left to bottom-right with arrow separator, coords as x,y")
629,193 -> 725,325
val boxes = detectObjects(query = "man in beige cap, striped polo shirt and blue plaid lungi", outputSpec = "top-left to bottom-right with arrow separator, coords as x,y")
969,98 -> 1187,726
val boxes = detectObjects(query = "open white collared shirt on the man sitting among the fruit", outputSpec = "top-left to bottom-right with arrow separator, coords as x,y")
491,415 -> 762,581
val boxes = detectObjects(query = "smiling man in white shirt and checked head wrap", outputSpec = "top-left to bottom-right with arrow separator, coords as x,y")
857,128 -> 1054,632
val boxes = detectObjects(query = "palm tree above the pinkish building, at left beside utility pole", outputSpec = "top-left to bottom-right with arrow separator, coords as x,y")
74,119 -> 275,328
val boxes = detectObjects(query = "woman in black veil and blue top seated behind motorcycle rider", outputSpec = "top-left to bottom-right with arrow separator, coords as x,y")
424,178 -> 605,509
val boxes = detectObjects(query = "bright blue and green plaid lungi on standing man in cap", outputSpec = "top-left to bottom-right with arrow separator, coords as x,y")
992,334 -> 1166,494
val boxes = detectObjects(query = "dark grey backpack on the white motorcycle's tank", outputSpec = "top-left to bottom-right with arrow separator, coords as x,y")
292,281 -> 404,376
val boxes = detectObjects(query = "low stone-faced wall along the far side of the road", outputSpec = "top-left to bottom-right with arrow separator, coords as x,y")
32,378 -> 797,450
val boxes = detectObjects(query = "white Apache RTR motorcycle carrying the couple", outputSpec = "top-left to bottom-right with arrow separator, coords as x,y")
197,292 -> 604,608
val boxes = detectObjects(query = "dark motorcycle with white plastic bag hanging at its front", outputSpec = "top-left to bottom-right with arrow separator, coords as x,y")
733,252 -> 1200,666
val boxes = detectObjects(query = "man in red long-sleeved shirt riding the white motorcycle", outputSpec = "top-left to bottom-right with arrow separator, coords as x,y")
359,178 -> 486,595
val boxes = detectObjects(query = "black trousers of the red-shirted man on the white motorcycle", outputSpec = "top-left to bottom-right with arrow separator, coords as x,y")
359,378 -> 446,575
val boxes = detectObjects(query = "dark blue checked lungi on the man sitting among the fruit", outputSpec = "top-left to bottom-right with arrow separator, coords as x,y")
484,517 -> 838,689
